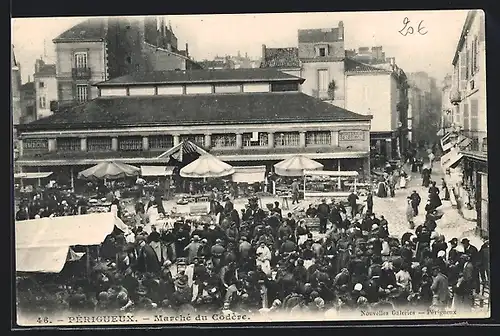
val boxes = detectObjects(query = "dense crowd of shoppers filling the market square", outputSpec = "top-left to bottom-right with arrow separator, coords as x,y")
16,167 -> 489,314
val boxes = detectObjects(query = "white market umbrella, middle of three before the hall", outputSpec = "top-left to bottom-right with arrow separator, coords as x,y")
180,154 -> 234,178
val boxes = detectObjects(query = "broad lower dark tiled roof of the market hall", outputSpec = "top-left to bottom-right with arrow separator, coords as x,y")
21,92 -> 371,130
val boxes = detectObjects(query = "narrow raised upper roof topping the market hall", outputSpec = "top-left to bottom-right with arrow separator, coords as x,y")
96,69 -> 303,86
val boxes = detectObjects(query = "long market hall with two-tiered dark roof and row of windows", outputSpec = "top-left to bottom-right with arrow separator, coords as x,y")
18,69 -> 371,185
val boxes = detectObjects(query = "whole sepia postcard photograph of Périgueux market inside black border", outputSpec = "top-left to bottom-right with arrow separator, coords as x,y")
11,10 -> 490,327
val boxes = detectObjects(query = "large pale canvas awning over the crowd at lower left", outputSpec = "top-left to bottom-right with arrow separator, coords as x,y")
15,212 -> 115,273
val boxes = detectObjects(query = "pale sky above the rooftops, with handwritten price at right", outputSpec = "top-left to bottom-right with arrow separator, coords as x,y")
12,10 -> 467,83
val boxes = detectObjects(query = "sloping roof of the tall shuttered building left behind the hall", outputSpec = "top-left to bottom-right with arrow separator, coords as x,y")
52,18 -> 106,43
